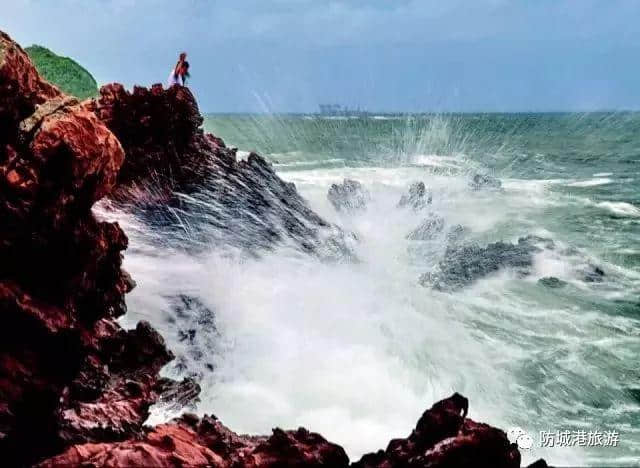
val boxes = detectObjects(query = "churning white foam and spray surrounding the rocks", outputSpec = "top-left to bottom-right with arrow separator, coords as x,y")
116,162 -> 637,464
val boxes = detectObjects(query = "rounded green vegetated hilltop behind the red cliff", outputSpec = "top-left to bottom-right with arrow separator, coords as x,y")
25,45 -> 98,99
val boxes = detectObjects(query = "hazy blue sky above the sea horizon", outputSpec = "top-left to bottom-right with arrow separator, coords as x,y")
5,0 -> 640,112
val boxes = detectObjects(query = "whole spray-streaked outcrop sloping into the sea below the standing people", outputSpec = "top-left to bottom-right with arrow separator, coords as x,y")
92,84 -> 354,260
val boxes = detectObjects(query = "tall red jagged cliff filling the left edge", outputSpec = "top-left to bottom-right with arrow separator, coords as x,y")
0,33 -> 171,465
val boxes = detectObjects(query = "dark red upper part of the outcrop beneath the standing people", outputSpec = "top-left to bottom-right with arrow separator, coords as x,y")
87,83 -> 234,198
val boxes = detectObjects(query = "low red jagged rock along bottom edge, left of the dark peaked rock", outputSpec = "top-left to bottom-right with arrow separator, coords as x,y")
39,414 -> 349,468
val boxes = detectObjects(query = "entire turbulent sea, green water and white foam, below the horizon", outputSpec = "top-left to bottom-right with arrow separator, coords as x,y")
119,113 -> 640,466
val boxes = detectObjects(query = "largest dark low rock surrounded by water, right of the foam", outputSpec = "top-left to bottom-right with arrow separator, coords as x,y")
420,238 -> 541,290
